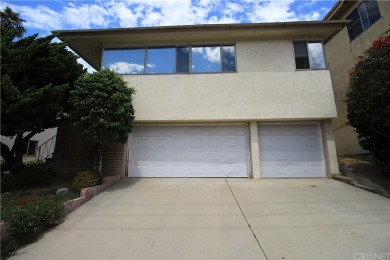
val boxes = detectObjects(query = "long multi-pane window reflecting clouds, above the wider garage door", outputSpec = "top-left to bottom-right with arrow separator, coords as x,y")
102,45 -> 236,74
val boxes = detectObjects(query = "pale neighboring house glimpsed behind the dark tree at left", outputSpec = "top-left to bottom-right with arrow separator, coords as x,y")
1,128 -> 57,162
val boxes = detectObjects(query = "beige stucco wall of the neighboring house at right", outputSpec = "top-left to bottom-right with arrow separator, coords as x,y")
325,1 -> 390,154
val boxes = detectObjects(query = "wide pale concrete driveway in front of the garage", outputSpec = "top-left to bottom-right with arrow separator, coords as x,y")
11,179 -> 390,260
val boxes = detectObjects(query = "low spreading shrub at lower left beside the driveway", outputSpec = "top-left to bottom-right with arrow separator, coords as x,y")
1,194 -> 65,242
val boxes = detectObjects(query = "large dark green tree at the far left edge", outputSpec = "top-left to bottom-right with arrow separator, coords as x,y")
0,8 -> 85,172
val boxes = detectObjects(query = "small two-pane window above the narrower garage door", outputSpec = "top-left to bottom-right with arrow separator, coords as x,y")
294,42 -> 326,70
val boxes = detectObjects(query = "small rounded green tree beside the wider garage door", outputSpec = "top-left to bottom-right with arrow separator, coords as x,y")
70,70 -> 134,171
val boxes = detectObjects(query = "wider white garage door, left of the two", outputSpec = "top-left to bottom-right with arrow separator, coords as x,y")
128,125 -> 248,177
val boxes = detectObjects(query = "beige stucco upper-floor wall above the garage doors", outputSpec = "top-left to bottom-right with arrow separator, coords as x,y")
124,40 -> 336,122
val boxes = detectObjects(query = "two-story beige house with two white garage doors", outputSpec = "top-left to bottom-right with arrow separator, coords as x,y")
53,21 -> 347,178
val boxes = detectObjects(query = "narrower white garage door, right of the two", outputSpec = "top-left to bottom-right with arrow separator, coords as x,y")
258,123 -> 325,178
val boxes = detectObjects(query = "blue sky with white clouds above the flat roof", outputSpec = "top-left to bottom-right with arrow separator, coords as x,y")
0,0 -> 336,71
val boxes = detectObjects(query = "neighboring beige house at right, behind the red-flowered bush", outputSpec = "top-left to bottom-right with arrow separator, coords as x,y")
324,0 -> 390,154
